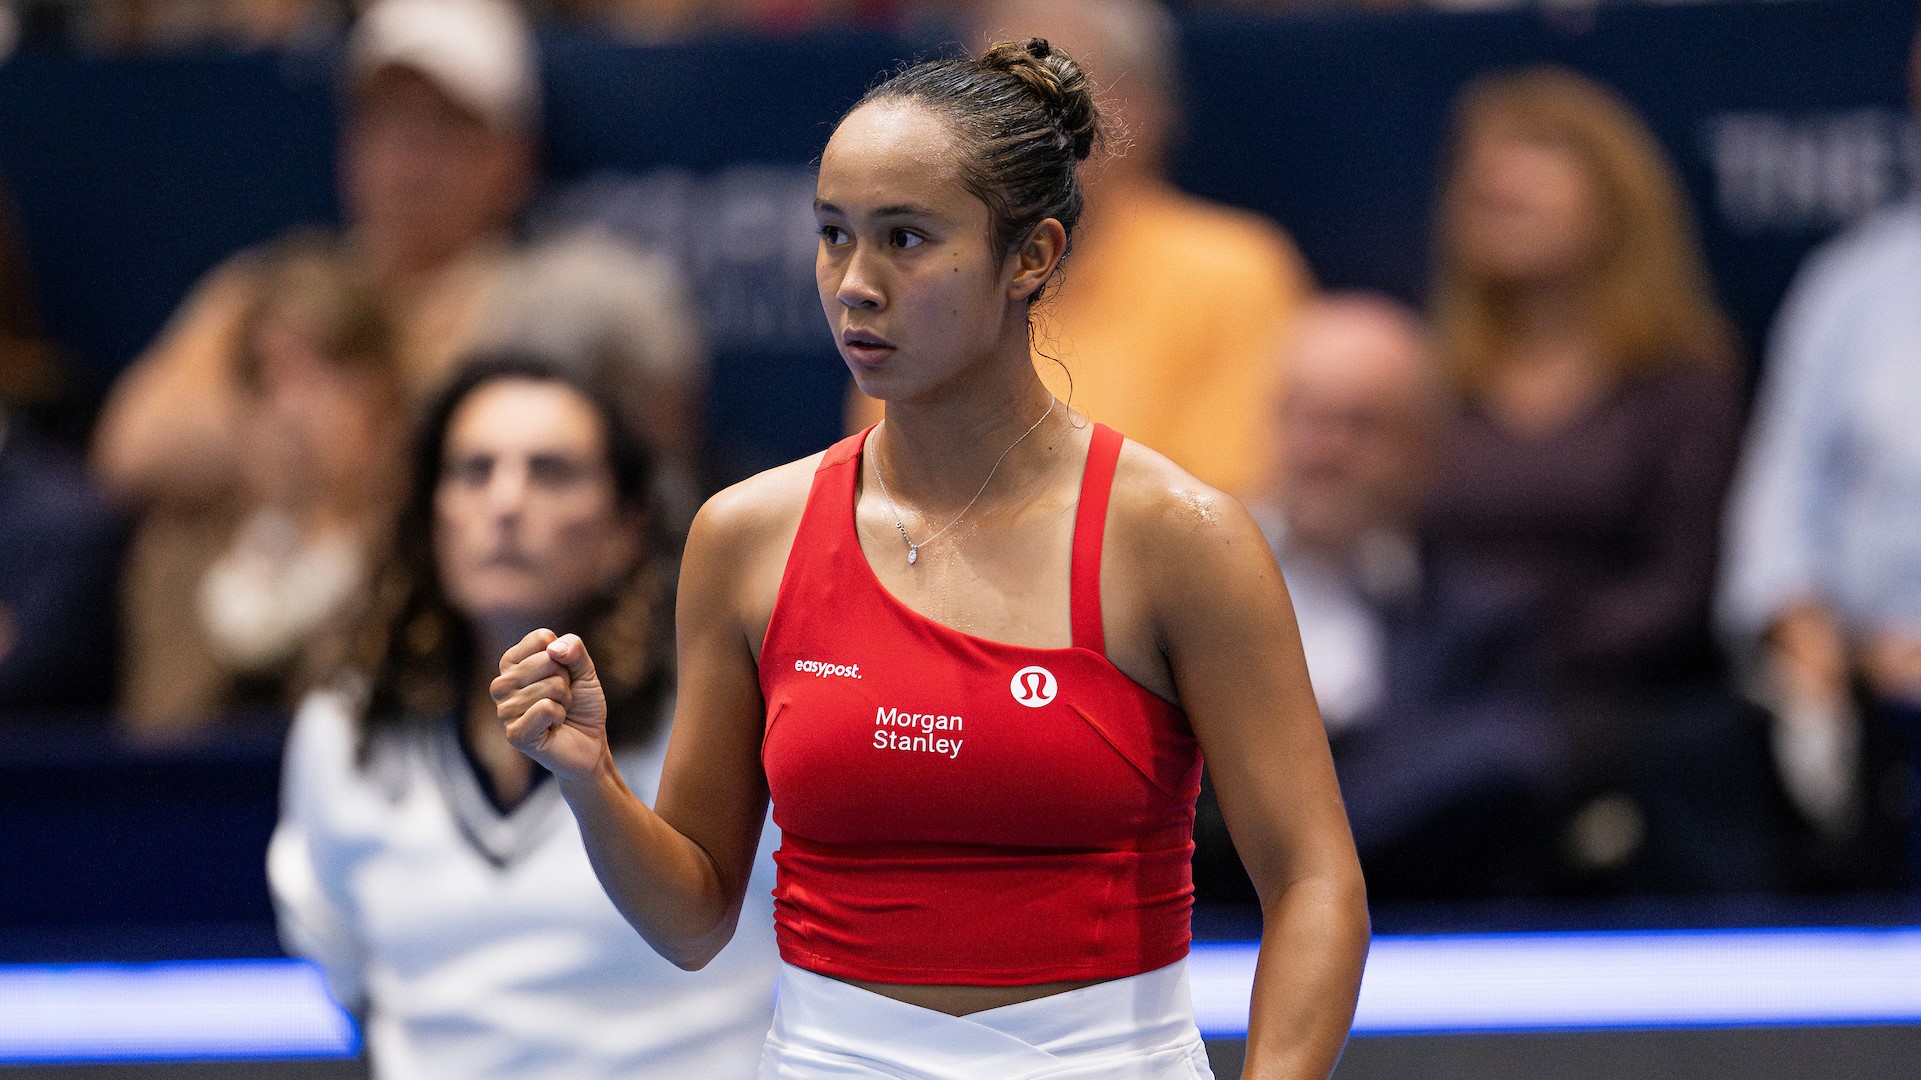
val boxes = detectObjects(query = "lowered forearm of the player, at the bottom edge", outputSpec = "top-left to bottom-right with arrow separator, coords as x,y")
1241,874 -> 1370,1080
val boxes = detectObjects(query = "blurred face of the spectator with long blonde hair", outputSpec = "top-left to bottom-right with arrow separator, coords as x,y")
1450,123 -> 1604,284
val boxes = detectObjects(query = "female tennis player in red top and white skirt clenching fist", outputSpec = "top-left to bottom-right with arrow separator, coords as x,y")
494,38 -> 1368,1080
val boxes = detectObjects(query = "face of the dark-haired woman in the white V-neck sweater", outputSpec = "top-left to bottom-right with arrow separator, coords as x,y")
434,379 -> 640,636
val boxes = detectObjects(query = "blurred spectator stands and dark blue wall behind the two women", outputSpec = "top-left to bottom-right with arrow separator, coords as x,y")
0,0 -> 1921,976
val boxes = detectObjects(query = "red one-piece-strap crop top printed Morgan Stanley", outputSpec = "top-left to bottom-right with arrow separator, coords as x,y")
761,425 -> 1201,986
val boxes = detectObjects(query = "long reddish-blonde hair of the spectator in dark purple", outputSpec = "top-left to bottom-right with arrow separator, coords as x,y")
1433,67 -> 1735,388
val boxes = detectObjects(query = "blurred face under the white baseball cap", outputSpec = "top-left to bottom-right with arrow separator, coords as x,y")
342,67 -> 532,273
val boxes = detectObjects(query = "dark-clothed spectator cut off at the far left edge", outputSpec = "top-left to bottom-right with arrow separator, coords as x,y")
0,176 -> 123,713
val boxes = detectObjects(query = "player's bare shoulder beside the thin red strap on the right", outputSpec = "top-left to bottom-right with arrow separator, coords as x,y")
1106,432 -> 1274,586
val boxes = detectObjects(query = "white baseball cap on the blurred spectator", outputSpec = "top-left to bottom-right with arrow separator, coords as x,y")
348,0 -> 540,129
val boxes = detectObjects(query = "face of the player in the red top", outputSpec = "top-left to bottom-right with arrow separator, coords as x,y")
815,102 -> 1032,400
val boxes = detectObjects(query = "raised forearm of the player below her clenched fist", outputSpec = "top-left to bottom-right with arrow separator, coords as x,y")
561,755 -> 742,970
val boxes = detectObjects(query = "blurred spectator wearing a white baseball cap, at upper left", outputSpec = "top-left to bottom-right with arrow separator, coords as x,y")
94,0 -> 538,736
